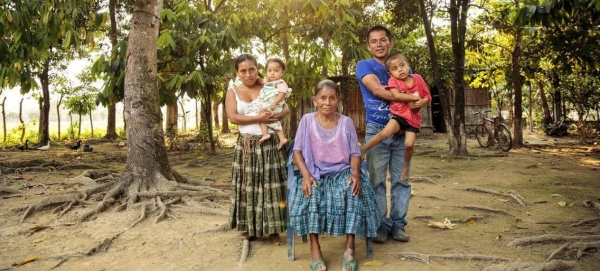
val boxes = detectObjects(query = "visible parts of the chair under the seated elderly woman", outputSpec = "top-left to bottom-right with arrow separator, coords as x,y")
286,140 -> 373,261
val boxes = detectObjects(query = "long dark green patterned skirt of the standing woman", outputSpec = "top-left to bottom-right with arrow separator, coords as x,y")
229,134 -> 287,237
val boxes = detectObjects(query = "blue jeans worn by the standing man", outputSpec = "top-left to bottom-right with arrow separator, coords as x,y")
365,123 -> 411,232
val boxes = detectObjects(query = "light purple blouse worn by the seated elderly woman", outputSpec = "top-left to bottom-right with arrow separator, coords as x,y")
294,113 -> 360,180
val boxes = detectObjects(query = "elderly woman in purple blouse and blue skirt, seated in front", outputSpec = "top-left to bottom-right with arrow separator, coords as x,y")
288,80 -> 379,270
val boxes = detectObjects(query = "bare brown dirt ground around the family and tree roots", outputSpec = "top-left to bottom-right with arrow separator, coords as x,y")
0,132 -> 600,271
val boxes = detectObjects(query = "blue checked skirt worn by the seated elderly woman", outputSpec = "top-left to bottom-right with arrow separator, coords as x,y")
288,168 -> 379,238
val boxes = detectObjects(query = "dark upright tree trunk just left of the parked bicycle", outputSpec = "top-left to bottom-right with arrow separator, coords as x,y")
448,0 -> 469,155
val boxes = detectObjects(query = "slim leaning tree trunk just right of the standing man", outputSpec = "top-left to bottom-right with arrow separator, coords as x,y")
419,0 -> 452,143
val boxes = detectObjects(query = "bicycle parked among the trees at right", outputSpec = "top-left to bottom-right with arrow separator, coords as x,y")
473,110 -> 512,152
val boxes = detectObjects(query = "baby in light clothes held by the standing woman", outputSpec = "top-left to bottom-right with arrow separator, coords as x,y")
258,58 -> 292,150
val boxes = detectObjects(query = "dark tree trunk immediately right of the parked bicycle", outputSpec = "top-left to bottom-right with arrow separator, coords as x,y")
510,0 -> 523,147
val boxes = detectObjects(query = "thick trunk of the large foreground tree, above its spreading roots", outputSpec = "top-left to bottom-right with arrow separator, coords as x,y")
120,0 -> 174,192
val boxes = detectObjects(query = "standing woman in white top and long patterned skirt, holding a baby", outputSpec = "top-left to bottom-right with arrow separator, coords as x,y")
225,54 -> 289,245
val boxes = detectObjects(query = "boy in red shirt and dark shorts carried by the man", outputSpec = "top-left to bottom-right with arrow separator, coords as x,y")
361,53 -> 431,181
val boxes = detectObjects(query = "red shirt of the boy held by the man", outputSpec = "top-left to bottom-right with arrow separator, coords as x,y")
388,74 -> 431,128
